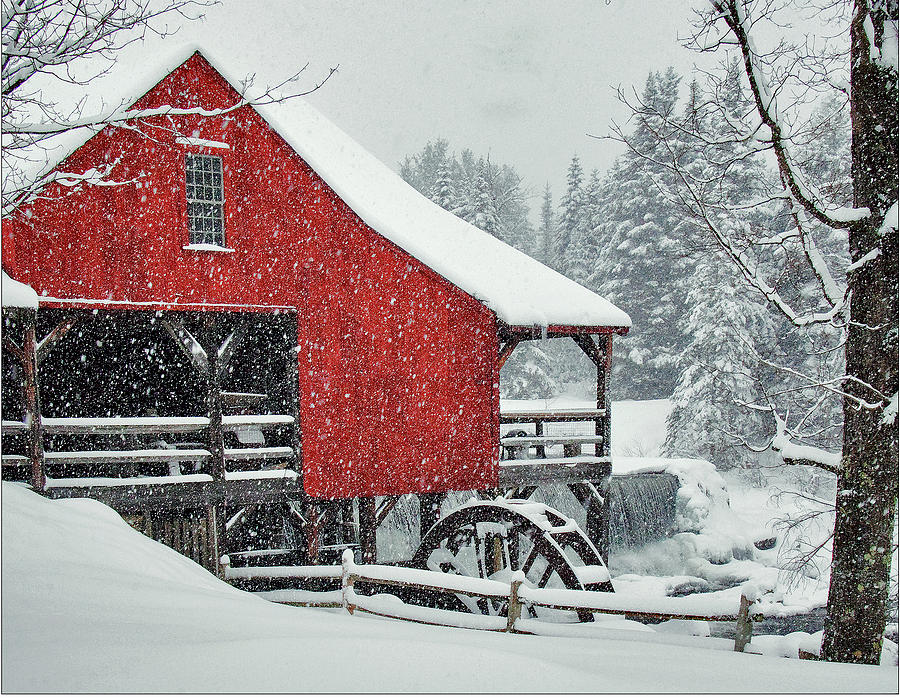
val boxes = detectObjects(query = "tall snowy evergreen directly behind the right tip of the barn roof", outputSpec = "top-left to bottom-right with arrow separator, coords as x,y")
588,68 -> 696,399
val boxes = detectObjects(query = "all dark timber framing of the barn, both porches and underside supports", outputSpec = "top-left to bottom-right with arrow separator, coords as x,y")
3,308 -> 626,573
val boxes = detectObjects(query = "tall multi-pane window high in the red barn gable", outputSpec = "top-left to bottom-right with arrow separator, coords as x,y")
185,154 -> 225,247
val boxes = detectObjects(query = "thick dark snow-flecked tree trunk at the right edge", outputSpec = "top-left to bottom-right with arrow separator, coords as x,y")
823,0 -> 898,664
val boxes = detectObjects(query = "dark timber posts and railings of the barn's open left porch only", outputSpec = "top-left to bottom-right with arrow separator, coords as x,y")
3,307 -> 305,573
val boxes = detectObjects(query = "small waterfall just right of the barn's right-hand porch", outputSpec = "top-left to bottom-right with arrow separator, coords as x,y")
609,473 -> 681,550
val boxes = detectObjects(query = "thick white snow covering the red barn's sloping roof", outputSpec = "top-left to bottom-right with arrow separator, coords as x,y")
7,47 -> 631,327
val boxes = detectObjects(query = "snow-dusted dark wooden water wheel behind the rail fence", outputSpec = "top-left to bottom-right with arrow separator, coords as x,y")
412,499 -> 613,622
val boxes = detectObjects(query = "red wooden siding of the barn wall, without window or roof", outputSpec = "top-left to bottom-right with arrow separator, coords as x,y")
3,55 -> 499,497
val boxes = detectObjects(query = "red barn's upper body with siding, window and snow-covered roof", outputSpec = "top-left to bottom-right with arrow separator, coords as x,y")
2,52 -> 630,568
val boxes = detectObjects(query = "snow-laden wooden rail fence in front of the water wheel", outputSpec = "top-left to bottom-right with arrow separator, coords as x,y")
223,550 -> 770,652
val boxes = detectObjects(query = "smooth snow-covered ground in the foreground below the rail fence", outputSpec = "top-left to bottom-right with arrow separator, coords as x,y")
2,483 -> 898,693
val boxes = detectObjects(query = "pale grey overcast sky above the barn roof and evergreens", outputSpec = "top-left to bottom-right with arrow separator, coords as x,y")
84,0 -> 697,209
